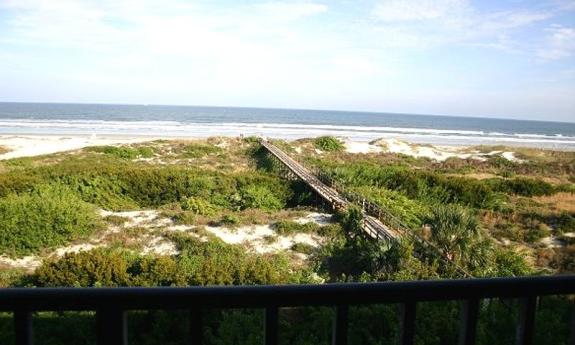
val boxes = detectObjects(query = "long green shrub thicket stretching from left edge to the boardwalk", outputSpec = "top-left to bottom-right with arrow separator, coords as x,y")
0,155 -> 297,211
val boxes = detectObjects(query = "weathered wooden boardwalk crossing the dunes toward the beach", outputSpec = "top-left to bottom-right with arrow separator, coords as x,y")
260,139 -> 400,240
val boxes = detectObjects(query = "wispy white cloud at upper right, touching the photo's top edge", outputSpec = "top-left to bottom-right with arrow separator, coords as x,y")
371,0 -> 566,54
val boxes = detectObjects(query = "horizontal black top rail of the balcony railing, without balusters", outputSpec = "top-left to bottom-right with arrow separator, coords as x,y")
0,275 -> 575,311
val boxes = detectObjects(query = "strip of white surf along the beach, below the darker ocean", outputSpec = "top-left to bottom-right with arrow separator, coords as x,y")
0,114 -> 575,151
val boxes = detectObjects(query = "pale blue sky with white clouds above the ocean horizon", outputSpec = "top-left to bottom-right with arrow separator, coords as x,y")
0,0 -> 575,122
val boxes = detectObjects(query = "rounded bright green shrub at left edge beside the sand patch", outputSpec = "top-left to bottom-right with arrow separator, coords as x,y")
0,185 -> 100,255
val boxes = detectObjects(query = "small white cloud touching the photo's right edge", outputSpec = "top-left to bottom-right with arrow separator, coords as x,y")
537,26 -> 575,60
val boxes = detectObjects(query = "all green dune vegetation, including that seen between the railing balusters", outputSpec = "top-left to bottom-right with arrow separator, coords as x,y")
0,137 -> 575,345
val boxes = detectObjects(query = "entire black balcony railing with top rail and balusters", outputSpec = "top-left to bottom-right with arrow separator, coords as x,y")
0,275 -> 575,345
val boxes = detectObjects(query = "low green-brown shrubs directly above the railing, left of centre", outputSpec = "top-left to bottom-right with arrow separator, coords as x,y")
32,235 -> 310,287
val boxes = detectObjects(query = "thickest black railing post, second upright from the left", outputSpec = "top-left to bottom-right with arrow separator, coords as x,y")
96,309 -> 128,345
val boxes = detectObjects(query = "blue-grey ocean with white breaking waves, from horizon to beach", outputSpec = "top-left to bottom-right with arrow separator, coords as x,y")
0,103 -> 575,150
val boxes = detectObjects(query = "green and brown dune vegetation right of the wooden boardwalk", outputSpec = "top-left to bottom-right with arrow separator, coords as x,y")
302,148 -> 575,271
